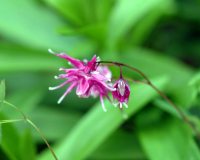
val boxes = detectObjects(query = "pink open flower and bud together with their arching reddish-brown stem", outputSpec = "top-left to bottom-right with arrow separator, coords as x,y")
49,50 -> 200,140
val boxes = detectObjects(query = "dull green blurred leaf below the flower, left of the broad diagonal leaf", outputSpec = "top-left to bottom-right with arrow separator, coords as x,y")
30,106 -> 81,142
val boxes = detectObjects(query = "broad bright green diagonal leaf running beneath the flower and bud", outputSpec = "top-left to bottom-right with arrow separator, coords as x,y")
38,77 -> 167,160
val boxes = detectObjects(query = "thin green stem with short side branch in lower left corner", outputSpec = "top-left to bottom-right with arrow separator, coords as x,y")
3,100 -> 58,160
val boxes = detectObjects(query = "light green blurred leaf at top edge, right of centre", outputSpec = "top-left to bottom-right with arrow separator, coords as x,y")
108,0 -> 170,47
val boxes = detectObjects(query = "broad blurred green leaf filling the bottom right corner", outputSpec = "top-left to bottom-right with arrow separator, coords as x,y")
139,120 -> 200,160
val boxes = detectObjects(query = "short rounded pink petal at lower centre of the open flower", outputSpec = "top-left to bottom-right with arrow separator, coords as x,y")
76,78 -> 89,96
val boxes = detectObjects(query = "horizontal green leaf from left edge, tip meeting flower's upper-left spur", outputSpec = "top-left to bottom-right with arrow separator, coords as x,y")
0,44 -> 61,72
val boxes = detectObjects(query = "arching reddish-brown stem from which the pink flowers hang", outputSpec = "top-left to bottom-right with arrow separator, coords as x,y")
98,61 -> 200,138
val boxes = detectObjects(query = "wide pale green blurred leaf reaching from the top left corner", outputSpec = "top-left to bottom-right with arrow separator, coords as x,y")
0,0 -> 93,52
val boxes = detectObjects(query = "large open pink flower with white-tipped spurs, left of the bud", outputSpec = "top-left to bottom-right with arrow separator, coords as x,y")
49,50 -> 115,111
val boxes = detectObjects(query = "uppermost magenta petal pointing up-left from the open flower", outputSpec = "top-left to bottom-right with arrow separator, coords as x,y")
56,53 -> 84,68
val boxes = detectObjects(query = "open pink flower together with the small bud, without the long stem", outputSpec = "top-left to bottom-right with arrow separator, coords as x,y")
49,50 -> 130,112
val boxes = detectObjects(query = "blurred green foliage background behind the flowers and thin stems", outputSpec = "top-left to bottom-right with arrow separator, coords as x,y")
0,0 -> 200,160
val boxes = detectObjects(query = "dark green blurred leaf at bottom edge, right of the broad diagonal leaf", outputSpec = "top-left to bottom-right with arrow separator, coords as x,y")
89,130 -> 145,160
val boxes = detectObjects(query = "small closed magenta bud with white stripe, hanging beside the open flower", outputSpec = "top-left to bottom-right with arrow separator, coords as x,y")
112,78 -> 130,108
